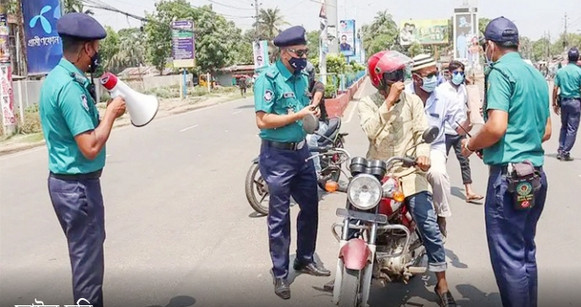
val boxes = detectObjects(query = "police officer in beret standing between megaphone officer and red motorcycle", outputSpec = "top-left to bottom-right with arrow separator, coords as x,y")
254,26 -> 331,299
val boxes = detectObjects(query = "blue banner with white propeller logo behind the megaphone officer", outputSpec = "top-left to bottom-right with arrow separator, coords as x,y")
22,0 -> 63,75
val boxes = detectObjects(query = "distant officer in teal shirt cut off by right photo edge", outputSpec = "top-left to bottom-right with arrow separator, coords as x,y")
553,48 -> 581,161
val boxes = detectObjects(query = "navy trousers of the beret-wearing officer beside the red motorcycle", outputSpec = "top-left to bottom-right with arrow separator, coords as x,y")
258,144 -> 319,278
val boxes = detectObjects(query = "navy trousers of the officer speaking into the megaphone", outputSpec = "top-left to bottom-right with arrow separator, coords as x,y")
48,176 -> 105,307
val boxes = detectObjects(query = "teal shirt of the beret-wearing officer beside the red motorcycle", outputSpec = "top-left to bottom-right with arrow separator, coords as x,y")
254,59 -> 310,142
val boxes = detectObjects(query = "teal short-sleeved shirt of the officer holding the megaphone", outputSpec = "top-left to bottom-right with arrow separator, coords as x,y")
39,58 -> 105,174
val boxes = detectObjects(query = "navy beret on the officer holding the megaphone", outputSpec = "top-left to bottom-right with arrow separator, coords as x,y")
56,13 -> 107,40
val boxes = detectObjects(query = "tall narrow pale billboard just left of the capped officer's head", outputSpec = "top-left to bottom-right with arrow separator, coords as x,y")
453,8 -> 479,63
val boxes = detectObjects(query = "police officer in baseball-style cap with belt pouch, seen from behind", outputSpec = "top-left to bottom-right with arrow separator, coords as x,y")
463,17 -> 551,307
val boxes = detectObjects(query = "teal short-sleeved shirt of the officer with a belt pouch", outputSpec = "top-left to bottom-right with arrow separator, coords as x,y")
483,52 -> 549,166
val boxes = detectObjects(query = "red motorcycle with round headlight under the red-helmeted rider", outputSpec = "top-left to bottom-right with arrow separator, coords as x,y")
314,127 -> 438,306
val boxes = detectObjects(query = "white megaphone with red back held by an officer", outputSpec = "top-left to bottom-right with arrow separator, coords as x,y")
100,72 -> 159,127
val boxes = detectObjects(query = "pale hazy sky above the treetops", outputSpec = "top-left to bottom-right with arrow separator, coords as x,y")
95,0 -> 581,40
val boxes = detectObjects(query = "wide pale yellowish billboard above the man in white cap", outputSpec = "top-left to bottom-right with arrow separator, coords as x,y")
399,19 -> 448,46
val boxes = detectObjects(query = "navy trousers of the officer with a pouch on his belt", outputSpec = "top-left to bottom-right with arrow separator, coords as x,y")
484,166 -> 547,307
